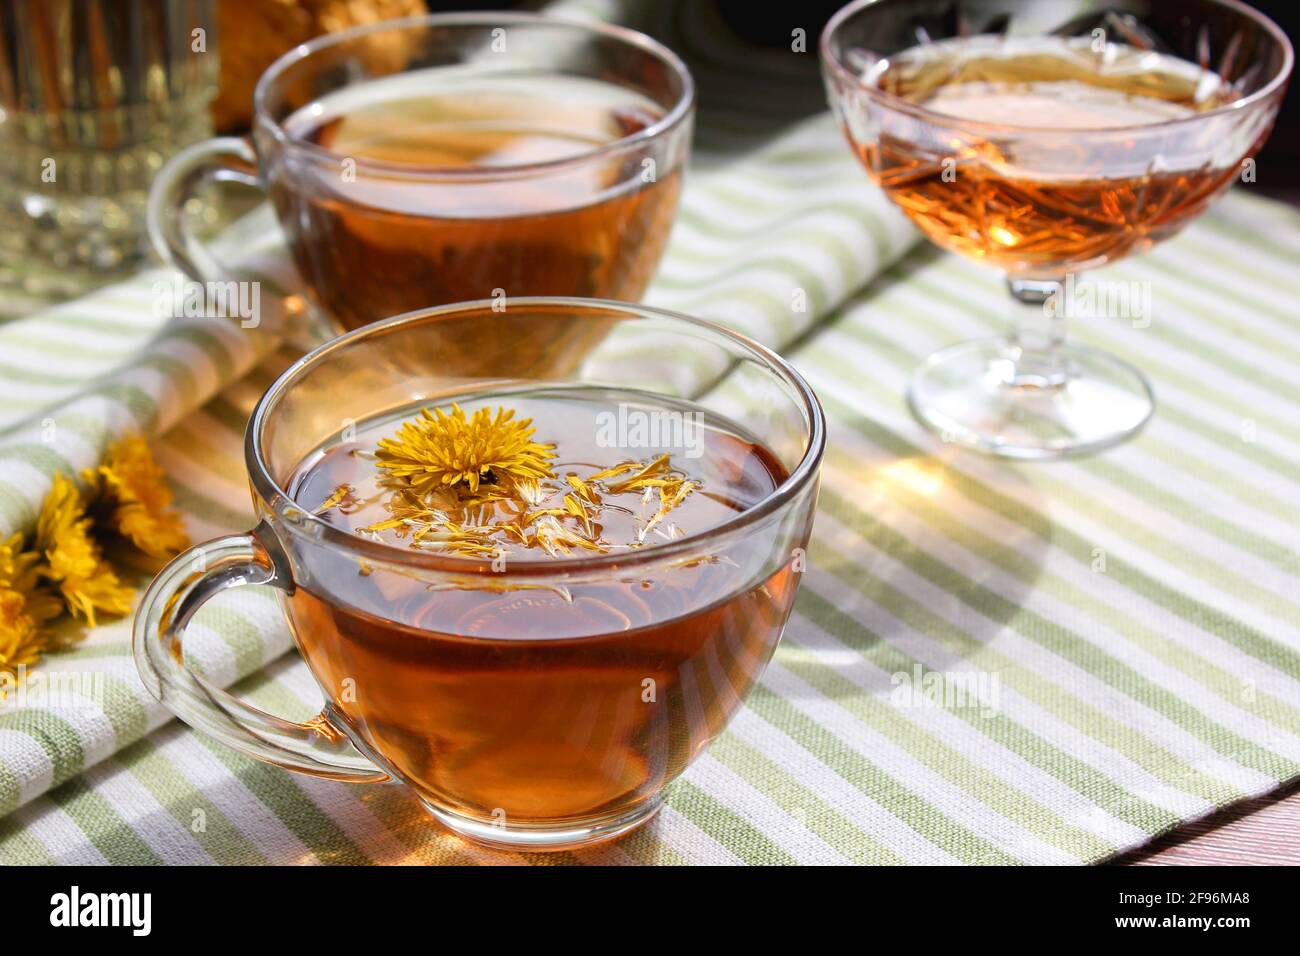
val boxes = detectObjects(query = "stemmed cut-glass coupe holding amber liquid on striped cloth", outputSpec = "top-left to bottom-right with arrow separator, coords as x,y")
822,0 -> 1294,459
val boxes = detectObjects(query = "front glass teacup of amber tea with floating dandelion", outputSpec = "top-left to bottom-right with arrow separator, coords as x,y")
134,298 -> 826,849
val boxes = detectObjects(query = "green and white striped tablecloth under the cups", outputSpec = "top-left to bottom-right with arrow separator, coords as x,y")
0,4 -> 1300,864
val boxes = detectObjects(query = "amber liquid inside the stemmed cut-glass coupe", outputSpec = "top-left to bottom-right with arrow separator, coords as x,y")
858,38 -> 1238,274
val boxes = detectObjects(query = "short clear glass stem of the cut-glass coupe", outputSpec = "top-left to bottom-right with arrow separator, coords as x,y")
1006,276 -> 1074,389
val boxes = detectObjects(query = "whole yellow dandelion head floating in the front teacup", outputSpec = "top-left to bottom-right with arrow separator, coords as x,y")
376,405 -> 555,494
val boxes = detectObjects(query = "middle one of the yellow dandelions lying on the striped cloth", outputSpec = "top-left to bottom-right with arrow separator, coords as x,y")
36,475 -> 133,627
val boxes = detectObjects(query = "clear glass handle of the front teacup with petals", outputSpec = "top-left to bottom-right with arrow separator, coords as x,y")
133,533 -> 390,783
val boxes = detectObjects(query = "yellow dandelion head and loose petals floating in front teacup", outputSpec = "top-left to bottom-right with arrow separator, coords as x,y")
340,405 -> 699,559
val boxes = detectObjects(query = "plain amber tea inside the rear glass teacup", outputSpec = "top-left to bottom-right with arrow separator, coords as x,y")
272,70 -> 680,328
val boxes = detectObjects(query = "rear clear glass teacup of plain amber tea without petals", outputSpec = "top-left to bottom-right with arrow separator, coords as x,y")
150,13 -> 694,330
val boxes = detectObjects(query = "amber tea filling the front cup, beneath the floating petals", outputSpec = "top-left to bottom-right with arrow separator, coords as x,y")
289,389 -> 796,822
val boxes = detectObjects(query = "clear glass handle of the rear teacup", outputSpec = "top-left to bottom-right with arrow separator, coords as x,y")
146,137 -> 267,282
